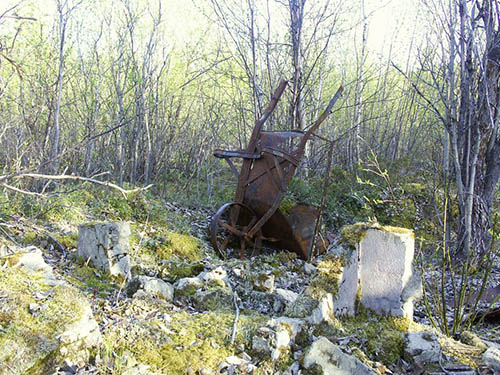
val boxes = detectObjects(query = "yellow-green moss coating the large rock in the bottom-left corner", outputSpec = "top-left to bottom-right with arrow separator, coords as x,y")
0,268 -> 85,374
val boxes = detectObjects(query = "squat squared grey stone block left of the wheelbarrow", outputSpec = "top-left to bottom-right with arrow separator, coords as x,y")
77,223 -> 130,278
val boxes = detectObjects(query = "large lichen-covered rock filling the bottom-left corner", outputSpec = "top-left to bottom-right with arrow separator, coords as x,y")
0,263 -> 101,374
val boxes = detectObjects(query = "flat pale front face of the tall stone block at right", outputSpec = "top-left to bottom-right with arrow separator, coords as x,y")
358,229 -> 415,319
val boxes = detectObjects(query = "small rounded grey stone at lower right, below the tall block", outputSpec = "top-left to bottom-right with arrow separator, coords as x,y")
405,331 -> 441,363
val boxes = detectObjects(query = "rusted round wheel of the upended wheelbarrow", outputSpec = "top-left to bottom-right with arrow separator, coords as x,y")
209,202 -> 260,258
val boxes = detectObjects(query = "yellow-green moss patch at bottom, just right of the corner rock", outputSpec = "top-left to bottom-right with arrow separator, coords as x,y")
101,312 -> 263,375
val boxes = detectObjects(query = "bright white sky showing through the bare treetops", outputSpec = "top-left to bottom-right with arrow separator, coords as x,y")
0,0 -> 426,66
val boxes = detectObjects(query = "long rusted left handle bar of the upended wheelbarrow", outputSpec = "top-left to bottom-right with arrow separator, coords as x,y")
231,80 -> 288,226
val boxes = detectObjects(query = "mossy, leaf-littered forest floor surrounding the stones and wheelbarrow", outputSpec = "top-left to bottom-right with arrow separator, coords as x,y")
0,186 -> 500,375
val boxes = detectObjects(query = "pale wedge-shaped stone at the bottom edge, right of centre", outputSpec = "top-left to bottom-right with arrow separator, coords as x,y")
303,337 -> 375,375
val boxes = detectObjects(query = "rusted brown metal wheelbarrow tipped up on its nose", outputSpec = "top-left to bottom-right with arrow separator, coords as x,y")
209,81 -> 342,259
